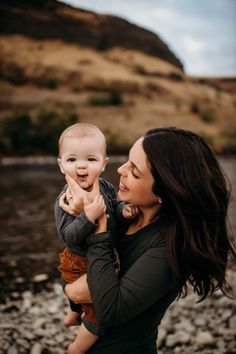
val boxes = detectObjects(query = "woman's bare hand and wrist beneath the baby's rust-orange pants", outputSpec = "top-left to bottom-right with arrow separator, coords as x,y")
65,274 -> 92,304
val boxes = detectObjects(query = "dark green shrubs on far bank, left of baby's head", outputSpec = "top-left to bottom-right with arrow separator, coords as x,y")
0,111 -> 78,155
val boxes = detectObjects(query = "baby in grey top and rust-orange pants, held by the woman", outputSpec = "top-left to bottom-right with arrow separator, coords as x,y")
55,123 -> 137,354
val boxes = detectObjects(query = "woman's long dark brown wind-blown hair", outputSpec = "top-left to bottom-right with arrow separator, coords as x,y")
143,128 -> 236,301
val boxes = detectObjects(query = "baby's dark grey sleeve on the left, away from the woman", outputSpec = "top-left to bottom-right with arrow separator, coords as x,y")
54,195 -> 97,246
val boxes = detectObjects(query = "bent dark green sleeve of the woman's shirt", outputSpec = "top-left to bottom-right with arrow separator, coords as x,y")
87,233 -> 174,326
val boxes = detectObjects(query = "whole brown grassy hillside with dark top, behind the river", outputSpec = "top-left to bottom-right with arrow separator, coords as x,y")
0,0 -> 236,152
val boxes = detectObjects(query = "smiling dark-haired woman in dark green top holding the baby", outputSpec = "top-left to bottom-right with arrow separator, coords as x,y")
62,128 -> 235,354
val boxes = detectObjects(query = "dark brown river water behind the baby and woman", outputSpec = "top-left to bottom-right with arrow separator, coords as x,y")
0,157 -> 236,295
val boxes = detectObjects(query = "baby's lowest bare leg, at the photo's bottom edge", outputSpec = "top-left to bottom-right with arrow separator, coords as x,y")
68,323 -> 98,354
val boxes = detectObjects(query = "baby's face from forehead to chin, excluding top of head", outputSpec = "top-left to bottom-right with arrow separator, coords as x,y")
58,137 -> 108,190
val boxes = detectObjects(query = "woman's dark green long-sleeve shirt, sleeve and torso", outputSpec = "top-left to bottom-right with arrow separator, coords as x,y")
87,219 -> 179,354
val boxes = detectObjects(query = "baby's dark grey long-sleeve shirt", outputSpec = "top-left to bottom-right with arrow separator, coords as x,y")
54,178 -> 123,255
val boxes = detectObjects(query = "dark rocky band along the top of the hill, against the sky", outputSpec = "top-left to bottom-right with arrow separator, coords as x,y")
0,0 -> 183,69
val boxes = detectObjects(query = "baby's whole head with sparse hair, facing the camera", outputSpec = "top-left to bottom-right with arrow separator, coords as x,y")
58,123 -> 108,190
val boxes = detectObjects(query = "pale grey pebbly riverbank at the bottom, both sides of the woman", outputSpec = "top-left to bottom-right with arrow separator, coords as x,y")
0,272 -> 236,354
